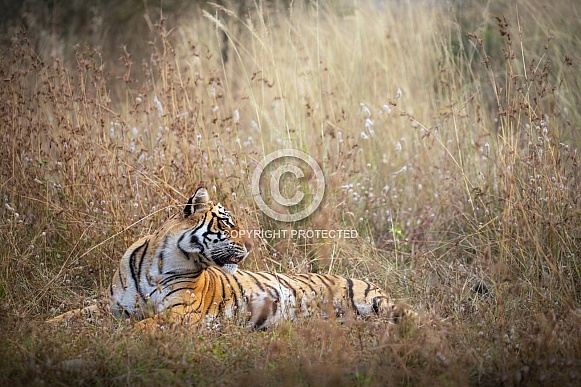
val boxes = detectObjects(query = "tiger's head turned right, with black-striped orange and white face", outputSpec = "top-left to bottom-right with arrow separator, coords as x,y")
177,188 -> 252,274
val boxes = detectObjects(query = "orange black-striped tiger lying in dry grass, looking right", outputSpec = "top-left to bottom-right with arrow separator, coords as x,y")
47,187 -> 417,330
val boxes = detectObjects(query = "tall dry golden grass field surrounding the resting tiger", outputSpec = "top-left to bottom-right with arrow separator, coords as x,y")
0,0 -> 581,386
